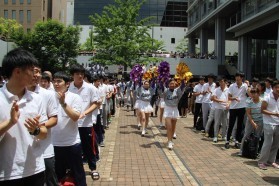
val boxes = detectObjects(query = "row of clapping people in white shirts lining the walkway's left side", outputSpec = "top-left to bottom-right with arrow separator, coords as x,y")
0,49 -> 127,186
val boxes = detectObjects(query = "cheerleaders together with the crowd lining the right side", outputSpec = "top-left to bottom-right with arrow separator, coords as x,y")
122,73 -> 279,169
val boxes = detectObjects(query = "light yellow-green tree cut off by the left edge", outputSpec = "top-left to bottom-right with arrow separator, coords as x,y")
0,17 -> 23,41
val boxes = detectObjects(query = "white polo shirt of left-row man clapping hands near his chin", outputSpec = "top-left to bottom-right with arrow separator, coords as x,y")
52,91 -> 82,147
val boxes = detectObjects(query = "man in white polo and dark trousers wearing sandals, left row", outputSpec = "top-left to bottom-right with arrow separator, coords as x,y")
69,65 -> 100,179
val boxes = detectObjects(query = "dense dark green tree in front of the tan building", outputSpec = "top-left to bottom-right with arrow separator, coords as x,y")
15,20 -> 80,72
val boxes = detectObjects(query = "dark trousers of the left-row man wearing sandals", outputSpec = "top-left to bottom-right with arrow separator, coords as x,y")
78,127 -> 97,170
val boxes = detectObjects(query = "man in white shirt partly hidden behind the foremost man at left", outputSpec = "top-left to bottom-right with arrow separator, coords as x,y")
27,65 -> 58,186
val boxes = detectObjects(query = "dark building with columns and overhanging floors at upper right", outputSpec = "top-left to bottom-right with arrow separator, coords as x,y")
186,0 -> 279,79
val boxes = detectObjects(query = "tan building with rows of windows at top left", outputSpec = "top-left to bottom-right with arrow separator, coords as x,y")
0,0 -> 68,32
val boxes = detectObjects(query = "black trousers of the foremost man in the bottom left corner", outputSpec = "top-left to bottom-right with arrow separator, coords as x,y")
0,172 -> 45,186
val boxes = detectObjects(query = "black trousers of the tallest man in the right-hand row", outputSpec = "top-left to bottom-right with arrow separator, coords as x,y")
227,108 -> 245,142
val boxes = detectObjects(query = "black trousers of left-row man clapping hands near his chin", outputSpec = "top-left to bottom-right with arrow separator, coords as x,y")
54,143 -> 86,186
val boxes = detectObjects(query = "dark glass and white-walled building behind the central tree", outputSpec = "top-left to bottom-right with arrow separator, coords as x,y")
73,0 -> 188,52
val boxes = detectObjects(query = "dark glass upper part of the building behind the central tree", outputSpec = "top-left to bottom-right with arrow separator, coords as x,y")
74,0 -> 188,27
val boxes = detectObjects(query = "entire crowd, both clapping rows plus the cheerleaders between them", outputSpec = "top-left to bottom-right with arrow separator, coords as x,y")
0,49 -> 279,186
